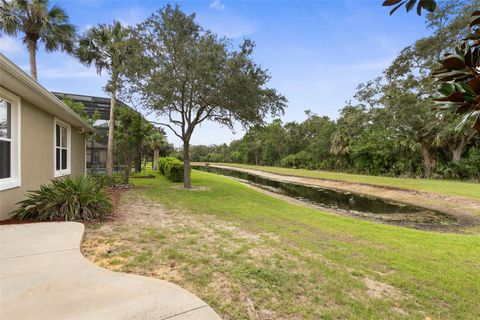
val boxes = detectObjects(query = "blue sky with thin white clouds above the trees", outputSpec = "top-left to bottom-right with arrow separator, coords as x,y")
0,0 -> 431,146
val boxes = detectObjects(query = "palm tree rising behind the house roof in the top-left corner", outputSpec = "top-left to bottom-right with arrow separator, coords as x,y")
0,0 -> 75,80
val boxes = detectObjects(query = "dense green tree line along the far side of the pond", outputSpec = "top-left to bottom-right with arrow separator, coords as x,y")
185,0 -> 480,179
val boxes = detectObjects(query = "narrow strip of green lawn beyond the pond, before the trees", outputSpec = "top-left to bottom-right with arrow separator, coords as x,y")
208,163 -> 480,200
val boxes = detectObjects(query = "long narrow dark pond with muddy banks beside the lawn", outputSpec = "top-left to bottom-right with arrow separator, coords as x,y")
192,166 -> 458,229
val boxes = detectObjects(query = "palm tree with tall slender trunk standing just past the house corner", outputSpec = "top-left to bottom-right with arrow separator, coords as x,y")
76,21 -> 131,176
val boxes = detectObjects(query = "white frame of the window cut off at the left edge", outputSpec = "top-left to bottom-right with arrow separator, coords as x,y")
0,87 -> 22,191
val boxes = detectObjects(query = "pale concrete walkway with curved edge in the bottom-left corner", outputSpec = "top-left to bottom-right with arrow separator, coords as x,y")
0,222 -> 220,320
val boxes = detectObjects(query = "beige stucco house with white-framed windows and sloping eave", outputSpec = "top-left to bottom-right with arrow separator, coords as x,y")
0,53 -> 95,220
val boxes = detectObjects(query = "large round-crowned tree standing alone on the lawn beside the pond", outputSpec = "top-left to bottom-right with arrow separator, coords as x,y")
124,6 -> 286,188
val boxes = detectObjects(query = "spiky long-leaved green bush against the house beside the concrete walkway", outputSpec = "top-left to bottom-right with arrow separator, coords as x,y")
12,175 -> 112,221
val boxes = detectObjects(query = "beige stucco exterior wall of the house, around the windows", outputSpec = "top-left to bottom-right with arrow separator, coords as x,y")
0,99 -> 85,220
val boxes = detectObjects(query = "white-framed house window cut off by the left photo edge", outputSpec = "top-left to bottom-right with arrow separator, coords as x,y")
0,87 -> 20,190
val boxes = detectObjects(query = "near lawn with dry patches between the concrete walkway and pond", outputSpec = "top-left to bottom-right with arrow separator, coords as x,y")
83,171 -> 480,320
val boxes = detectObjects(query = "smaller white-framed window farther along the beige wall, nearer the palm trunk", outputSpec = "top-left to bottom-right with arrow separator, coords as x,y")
54,119 -> 71,177
